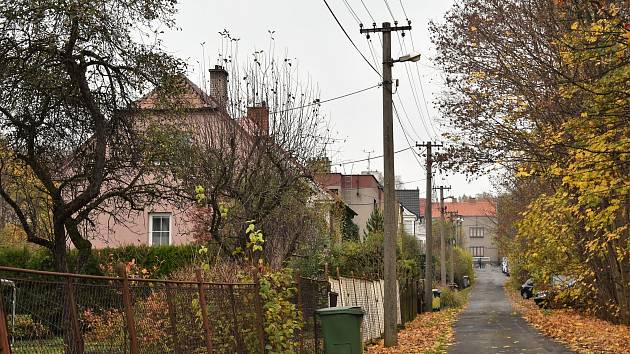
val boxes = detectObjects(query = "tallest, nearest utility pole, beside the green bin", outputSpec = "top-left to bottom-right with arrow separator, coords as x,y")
360,22 -> 411,347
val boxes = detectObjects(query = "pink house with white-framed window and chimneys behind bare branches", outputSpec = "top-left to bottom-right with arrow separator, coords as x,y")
88,66 -> 345,248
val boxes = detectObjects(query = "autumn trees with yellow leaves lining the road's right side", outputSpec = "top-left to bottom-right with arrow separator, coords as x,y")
432,0 -> 630,324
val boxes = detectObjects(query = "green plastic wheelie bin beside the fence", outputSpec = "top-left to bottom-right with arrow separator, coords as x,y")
317,306 -> 364,354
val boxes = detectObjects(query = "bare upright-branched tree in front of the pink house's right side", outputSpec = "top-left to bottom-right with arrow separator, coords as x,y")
192,39 -> 328,264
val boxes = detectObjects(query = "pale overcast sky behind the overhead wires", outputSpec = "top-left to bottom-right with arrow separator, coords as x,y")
164,0 -> 492,199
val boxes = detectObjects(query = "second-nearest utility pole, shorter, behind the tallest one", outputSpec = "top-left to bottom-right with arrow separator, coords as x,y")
416,141 -> 442,312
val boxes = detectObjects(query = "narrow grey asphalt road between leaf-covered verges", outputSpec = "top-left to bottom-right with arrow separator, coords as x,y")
448,266 -> 573,354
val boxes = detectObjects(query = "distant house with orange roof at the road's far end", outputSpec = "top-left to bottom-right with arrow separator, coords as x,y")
420,198 -> 499,263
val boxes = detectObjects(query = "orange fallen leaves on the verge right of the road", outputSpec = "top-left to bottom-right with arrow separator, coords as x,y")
506,288 -> 630,354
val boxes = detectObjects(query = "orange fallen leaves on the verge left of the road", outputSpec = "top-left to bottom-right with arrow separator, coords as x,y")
366,309 -> 462,354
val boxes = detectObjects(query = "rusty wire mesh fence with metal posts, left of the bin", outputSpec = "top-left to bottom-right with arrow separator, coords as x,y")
0,267 -> 329,354
